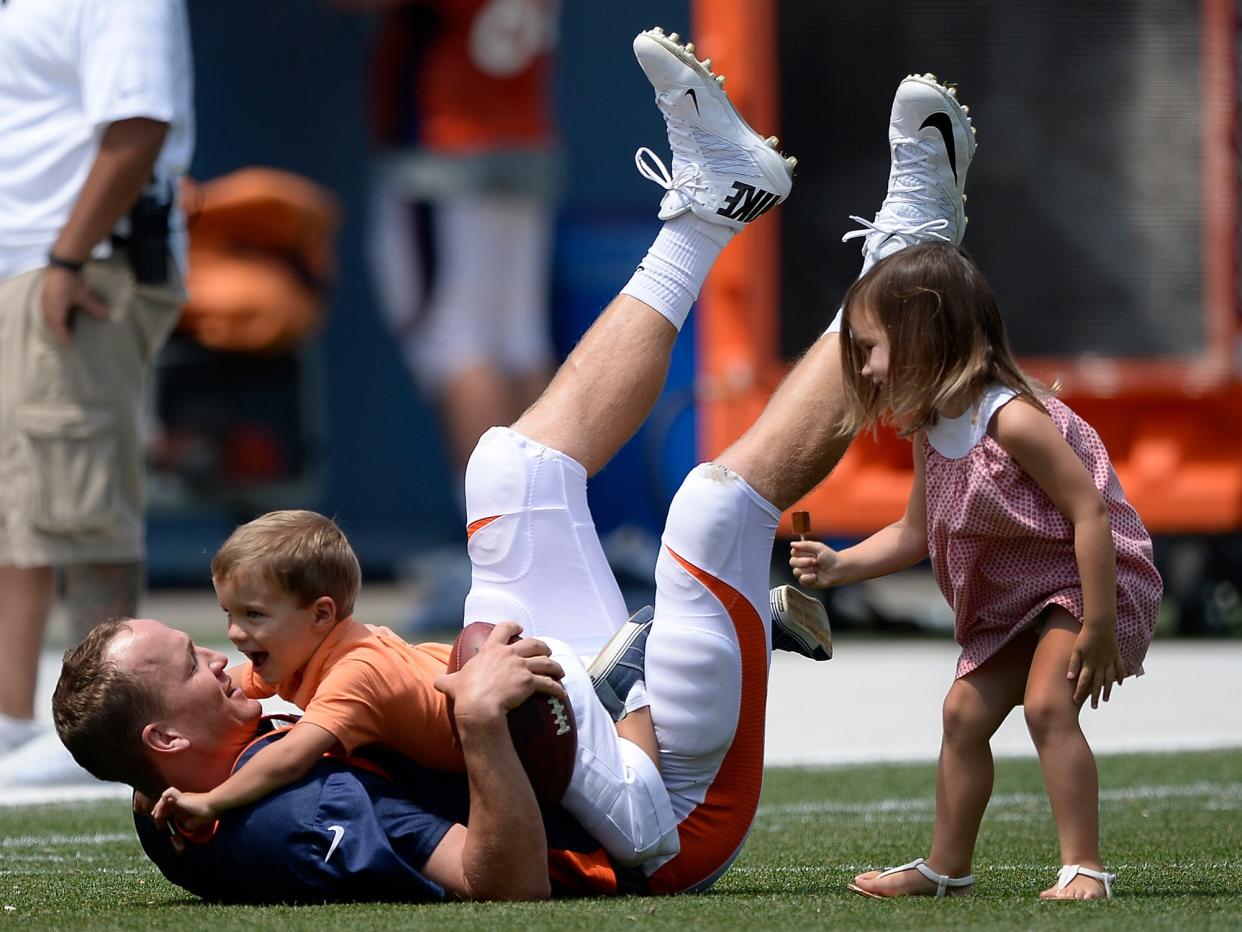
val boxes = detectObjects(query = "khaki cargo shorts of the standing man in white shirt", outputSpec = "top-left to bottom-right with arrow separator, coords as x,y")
0,256 -> 185,567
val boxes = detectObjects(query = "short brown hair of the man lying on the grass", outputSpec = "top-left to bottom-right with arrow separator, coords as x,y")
52,619 -> 168,798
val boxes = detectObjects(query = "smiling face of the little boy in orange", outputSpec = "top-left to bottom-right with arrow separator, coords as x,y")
211,573 -> 332,686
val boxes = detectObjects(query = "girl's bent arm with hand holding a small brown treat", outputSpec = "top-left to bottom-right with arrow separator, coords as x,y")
790,436 -> 928,587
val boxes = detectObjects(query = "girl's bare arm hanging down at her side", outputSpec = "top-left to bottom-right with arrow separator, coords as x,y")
995,399 -> 1125,707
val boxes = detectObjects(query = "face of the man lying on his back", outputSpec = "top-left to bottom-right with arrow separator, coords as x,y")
108,619 -> 262,754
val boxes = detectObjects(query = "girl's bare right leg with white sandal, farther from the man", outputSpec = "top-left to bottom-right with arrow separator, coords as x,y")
1025,608 -> 1104,900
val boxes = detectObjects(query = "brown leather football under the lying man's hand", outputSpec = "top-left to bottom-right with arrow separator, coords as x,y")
448,621 -> 578,805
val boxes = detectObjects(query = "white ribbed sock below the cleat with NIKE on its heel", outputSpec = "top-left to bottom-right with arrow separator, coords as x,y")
621,212 -> 733,332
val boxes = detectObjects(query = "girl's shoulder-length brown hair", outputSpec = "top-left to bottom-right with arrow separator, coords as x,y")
840,242 -> 1049,436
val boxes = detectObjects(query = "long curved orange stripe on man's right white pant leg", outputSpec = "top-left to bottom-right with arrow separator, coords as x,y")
650,549 -> 768,893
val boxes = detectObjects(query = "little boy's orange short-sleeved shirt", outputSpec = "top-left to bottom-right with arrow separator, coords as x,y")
229,618 -> 466,772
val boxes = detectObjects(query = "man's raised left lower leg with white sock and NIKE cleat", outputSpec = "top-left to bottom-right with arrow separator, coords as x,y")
514,30 -> 796,475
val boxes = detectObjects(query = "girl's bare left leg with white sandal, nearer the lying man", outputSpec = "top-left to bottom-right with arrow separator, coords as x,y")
854,636 -> 1035,896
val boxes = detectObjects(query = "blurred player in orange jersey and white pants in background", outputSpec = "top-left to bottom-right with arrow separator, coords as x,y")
345,0 -> 560,628
